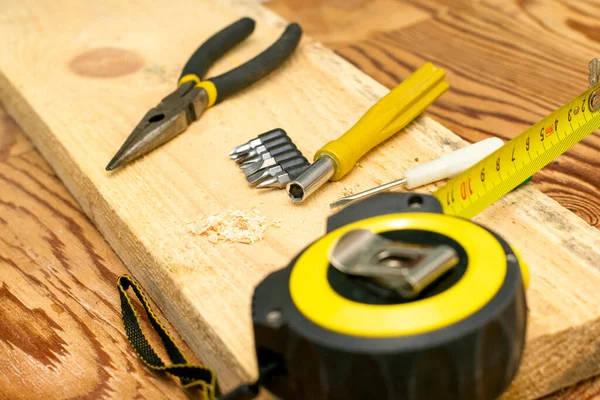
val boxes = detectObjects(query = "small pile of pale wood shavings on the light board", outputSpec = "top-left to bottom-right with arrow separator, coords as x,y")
190,207 -> 281,244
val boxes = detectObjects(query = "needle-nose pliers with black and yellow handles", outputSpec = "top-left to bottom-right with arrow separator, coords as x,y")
106,18 -> 302,171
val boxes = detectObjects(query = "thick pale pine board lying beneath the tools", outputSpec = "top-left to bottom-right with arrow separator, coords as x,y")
0,0 -> 600,398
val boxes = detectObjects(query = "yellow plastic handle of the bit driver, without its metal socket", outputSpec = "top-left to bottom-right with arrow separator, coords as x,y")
315,63 -> 449,181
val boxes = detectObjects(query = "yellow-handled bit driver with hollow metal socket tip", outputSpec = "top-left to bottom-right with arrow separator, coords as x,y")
286,63 -> 448,203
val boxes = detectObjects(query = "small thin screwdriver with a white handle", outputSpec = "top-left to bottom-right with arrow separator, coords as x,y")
329,137 -> 504,208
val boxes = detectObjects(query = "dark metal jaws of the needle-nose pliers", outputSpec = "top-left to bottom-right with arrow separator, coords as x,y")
106,82 -> 208,171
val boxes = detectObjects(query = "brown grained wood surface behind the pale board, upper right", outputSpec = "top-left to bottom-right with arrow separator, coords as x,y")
267,0 -> 600,227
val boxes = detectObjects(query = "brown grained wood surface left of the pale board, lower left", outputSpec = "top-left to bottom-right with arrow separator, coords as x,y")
0,109 -> 202,400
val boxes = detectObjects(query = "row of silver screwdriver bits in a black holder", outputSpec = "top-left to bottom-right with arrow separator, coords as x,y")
229,128 -> 310,189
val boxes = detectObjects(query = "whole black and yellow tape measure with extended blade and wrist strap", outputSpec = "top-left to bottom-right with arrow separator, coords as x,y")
119,59 -> 600,400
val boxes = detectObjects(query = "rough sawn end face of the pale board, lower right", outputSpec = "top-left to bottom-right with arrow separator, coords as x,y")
502,319 -> 600,400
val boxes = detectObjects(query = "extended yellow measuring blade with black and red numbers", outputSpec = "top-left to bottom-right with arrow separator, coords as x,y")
433,78 -> 600,218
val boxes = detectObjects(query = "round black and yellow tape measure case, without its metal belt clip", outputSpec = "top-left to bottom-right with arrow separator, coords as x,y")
252,193 -> 527,400
